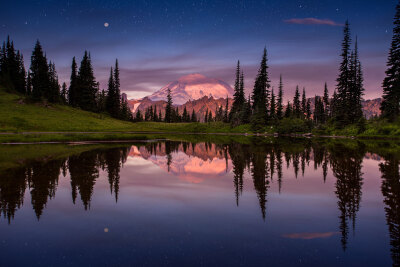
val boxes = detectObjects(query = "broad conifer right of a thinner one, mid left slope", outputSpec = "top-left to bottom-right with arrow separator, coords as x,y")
77,51 -> 98,111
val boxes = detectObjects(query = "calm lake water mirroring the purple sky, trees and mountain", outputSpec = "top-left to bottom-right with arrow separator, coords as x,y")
0,138 -> 400,266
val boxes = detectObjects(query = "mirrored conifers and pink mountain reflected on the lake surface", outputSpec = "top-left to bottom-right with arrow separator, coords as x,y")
0,138 -> 400,266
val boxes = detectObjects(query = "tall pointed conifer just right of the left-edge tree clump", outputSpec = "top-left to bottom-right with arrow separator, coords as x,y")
30,40 -> 50,100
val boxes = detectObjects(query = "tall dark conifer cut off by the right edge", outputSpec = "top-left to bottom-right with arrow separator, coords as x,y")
381,2 -> 400,121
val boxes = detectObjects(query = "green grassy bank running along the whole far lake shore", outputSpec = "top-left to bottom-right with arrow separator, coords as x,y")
0,88 -> 400,143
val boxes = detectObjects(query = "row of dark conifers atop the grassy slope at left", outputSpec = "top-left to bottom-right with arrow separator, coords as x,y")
0,37 -> 132,120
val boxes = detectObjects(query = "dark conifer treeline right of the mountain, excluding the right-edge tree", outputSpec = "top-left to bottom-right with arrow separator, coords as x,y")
222,22 -> 364,131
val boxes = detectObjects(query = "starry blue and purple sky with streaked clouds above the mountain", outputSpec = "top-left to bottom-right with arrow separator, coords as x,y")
0,0 -> 398,98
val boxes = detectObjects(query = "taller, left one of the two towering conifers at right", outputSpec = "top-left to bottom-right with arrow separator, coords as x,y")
335,21 -> 351,127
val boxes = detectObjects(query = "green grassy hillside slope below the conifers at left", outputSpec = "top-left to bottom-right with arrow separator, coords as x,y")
0,88 -> 135,132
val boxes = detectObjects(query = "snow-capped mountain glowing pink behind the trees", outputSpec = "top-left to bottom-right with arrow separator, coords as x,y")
148,74 -> 233,105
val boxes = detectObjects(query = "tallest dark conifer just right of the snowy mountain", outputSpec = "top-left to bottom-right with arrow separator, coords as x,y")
251,48 -> 270,131
